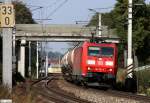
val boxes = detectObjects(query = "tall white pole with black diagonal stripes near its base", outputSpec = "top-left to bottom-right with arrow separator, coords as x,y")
127,0 -> 133,78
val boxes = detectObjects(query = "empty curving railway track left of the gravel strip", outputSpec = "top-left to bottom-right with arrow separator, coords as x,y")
32,75 -> 90,103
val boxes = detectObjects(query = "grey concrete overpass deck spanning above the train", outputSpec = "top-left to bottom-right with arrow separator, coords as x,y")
16,24 -> 117,42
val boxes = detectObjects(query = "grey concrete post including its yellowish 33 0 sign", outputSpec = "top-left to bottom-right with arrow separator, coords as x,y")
0,0 -> 15,90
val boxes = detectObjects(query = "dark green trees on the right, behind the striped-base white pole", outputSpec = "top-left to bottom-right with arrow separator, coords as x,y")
89,0 -> 150,63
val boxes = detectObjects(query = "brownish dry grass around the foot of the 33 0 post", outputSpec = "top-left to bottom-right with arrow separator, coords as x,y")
0,64 -> 36,103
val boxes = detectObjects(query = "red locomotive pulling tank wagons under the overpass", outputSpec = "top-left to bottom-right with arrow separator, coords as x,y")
61,41 -> 118,85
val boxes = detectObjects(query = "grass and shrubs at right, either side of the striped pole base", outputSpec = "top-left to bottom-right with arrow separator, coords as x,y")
117,68 -> 150,96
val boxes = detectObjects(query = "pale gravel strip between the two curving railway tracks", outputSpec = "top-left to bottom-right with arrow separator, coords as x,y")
58,80 -> 146,103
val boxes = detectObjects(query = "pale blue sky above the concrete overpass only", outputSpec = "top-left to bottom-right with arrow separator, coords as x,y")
26,0 -> 116,24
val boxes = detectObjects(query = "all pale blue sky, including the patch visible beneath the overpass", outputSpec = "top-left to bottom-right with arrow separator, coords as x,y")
23,0 -> 150,53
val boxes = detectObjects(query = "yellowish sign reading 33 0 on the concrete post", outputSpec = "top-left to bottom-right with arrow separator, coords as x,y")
0,4 -> 15,28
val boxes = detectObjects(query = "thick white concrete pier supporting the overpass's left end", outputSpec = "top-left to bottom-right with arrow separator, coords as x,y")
18,39 -> 26,77
